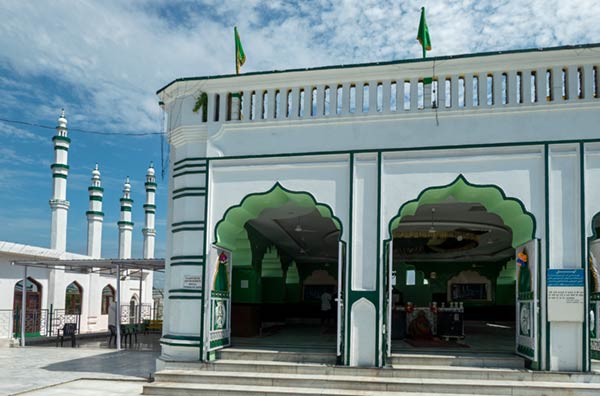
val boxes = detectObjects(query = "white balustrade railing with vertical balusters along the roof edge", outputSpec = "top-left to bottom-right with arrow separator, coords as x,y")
183,53 -> 600,127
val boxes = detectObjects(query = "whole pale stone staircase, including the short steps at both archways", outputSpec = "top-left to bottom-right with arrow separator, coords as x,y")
143,349 -> 600,396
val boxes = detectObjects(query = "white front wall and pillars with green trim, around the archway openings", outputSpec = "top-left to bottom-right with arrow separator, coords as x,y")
160,49 -> 600,371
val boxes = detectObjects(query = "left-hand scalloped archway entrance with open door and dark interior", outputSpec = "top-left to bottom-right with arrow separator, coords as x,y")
205,183 -> 345,356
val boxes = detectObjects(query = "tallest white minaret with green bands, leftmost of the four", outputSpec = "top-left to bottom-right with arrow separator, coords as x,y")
50,109 -> 71,252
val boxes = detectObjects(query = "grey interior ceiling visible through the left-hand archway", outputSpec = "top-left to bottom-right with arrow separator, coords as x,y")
248,202 -> 339,263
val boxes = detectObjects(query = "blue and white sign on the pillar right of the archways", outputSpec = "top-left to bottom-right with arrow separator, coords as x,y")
546,269 -> 585,322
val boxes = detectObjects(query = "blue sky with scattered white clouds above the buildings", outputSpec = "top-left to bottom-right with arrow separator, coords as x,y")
0,0 -> 600,257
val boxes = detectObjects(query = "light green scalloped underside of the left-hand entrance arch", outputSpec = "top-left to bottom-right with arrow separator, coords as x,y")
215,182 -> 343,248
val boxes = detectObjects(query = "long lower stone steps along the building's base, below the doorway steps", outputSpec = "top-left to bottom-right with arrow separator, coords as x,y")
144,370 -> 600,396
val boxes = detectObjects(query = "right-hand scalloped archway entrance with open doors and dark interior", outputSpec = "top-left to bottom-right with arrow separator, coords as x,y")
384,175 -> 539,364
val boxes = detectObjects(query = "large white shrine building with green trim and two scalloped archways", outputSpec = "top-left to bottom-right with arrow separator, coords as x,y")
156,44 -> 600,371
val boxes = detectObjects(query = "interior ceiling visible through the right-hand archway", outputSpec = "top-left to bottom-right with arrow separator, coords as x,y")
393,197 -> 514,262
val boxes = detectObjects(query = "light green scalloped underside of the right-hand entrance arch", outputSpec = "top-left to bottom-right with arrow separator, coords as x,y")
389,175 -> 536,247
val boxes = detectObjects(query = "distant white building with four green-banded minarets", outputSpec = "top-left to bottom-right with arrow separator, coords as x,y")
0,111 -> 157,344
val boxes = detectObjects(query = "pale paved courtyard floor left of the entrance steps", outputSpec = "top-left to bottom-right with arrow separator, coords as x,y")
0,342 -> 159,396
